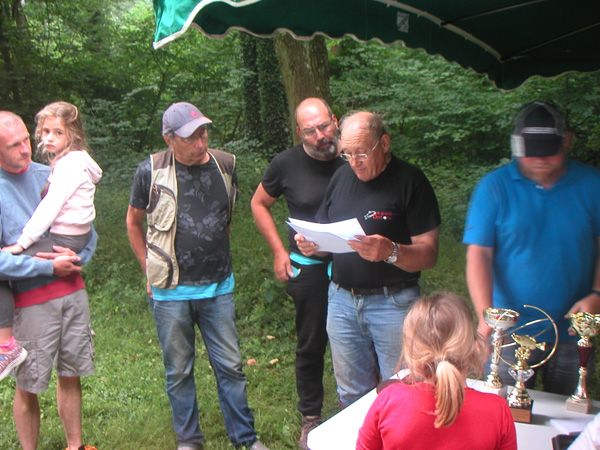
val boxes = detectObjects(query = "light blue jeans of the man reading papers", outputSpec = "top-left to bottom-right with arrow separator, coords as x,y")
327,282 -> 420,406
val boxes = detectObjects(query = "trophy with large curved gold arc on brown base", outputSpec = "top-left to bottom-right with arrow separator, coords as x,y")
500,305 -> 558,423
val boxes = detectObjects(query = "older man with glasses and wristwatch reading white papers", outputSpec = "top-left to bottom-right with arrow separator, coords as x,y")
295,111 -> 441,407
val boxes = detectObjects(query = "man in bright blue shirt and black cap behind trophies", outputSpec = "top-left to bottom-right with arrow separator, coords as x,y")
463,102 -> 600,395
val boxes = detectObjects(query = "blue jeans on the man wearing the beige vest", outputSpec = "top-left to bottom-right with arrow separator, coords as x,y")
151,294 -> 256,447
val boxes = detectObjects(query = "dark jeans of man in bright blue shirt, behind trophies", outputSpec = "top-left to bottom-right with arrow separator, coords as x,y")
485,340 -> 594,395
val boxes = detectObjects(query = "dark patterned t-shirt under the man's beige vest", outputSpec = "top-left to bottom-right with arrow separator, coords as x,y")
129,153 -> 236,286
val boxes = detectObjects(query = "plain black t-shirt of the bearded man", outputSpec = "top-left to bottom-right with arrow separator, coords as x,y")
262,145 -> 347,253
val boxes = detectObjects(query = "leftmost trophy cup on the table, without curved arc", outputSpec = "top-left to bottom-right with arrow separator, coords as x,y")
483,308 -> 519,397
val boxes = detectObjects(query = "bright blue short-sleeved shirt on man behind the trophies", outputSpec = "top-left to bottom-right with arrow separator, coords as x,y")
463,159 -> 600,340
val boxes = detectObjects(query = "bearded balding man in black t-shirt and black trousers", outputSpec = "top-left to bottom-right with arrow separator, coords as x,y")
251,98 -> 344,449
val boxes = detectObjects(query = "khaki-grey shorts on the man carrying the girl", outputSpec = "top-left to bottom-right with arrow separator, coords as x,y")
13,289 -> 95,394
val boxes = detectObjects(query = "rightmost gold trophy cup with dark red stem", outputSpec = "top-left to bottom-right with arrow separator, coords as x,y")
566,312 -> 600,414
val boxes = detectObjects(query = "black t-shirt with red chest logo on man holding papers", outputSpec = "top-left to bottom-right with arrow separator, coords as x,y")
317,157 -> 441,289
